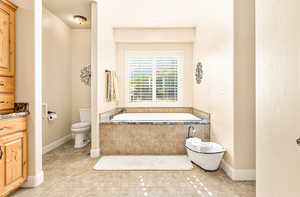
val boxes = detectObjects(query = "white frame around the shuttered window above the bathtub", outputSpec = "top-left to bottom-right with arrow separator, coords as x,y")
123,50 -> 184,107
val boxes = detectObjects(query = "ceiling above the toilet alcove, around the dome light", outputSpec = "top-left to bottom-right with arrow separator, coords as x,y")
44,0 -> 91,29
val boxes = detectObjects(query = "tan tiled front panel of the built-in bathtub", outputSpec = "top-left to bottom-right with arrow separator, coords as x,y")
100,124 -> 210,155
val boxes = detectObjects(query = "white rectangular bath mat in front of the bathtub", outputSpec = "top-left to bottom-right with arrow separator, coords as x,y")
94,155 -> 193,170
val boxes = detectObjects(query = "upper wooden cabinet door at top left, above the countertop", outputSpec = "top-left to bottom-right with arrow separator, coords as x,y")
0,1 -> 15,76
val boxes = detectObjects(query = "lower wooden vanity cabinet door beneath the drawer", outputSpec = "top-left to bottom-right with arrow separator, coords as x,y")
0,132 -> 27,197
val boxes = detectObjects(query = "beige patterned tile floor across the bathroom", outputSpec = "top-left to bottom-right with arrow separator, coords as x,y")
12,142 -> 255,197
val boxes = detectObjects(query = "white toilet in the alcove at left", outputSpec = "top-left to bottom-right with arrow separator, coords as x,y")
71,108 -> 91,148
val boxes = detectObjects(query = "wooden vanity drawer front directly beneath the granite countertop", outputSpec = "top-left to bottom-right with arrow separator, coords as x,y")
0,117 -> 27,136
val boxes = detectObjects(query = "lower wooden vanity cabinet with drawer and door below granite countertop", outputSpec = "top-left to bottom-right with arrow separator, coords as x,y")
0,117 -> 28,197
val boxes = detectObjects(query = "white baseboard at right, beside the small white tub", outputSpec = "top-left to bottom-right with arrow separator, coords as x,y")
221,160 -> 256,181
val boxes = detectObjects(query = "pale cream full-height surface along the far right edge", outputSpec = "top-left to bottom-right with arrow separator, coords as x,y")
256,0 -> 300,197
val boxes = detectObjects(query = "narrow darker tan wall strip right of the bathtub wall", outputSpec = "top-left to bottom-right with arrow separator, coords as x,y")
233,0 -> 255,169
